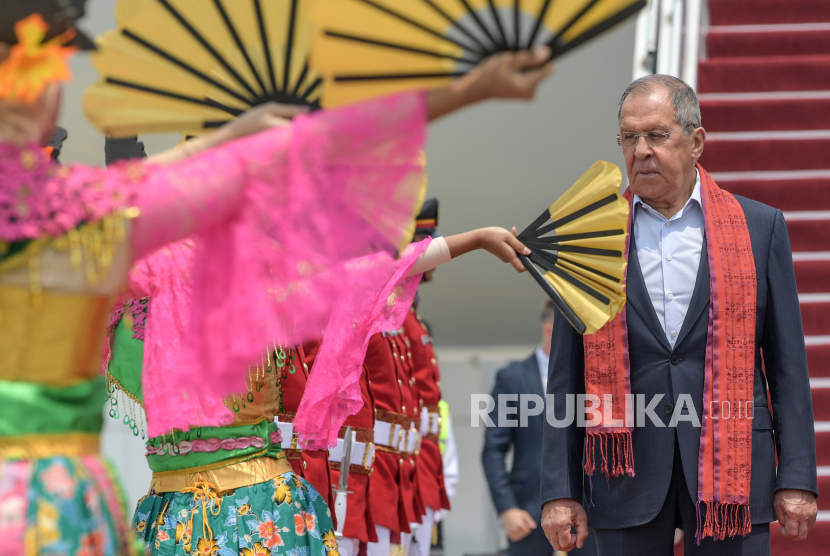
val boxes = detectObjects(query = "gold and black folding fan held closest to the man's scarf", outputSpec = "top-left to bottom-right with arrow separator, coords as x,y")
519,160 -> 629,334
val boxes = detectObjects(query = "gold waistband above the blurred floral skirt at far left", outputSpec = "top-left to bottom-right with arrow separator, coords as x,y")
0,432 -> 101,461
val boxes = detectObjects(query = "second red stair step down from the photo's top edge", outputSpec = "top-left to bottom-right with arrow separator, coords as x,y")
706,23 -> 830,58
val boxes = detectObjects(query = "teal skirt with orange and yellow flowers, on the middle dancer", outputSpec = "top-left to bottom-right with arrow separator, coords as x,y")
133,472 -> 339,556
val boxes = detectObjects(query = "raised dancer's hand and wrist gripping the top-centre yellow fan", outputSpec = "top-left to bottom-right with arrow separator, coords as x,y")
427,46 -> 553,120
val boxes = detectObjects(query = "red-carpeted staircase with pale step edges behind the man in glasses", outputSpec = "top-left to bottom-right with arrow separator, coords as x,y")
698,0 -> 830,556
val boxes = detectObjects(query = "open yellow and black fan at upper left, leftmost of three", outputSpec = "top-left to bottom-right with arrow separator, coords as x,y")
84,0 -> 324,137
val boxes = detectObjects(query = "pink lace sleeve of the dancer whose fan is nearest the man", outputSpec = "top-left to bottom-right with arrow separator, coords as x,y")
294,238 -> 432,450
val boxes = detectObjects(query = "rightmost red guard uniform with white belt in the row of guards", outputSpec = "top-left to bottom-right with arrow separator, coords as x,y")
403,309 -> 450,510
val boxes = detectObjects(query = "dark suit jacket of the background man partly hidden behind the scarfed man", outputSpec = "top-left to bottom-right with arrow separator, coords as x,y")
481,354 -> 545,523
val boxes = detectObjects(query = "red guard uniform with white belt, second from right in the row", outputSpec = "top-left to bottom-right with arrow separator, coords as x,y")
364,331 -> 423,535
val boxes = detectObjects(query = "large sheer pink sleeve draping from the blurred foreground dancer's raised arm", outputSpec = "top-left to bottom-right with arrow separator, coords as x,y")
133,93 -> 426,436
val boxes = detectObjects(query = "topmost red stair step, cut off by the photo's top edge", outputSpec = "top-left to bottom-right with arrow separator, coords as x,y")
709,0 -> 830,25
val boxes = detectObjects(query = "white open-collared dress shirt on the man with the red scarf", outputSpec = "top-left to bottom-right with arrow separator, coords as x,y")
633,173 -> 704,348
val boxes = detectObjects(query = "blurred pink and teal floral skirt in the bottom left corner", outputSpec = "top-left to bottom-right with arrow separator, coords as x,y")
0,456 -> 137,556
